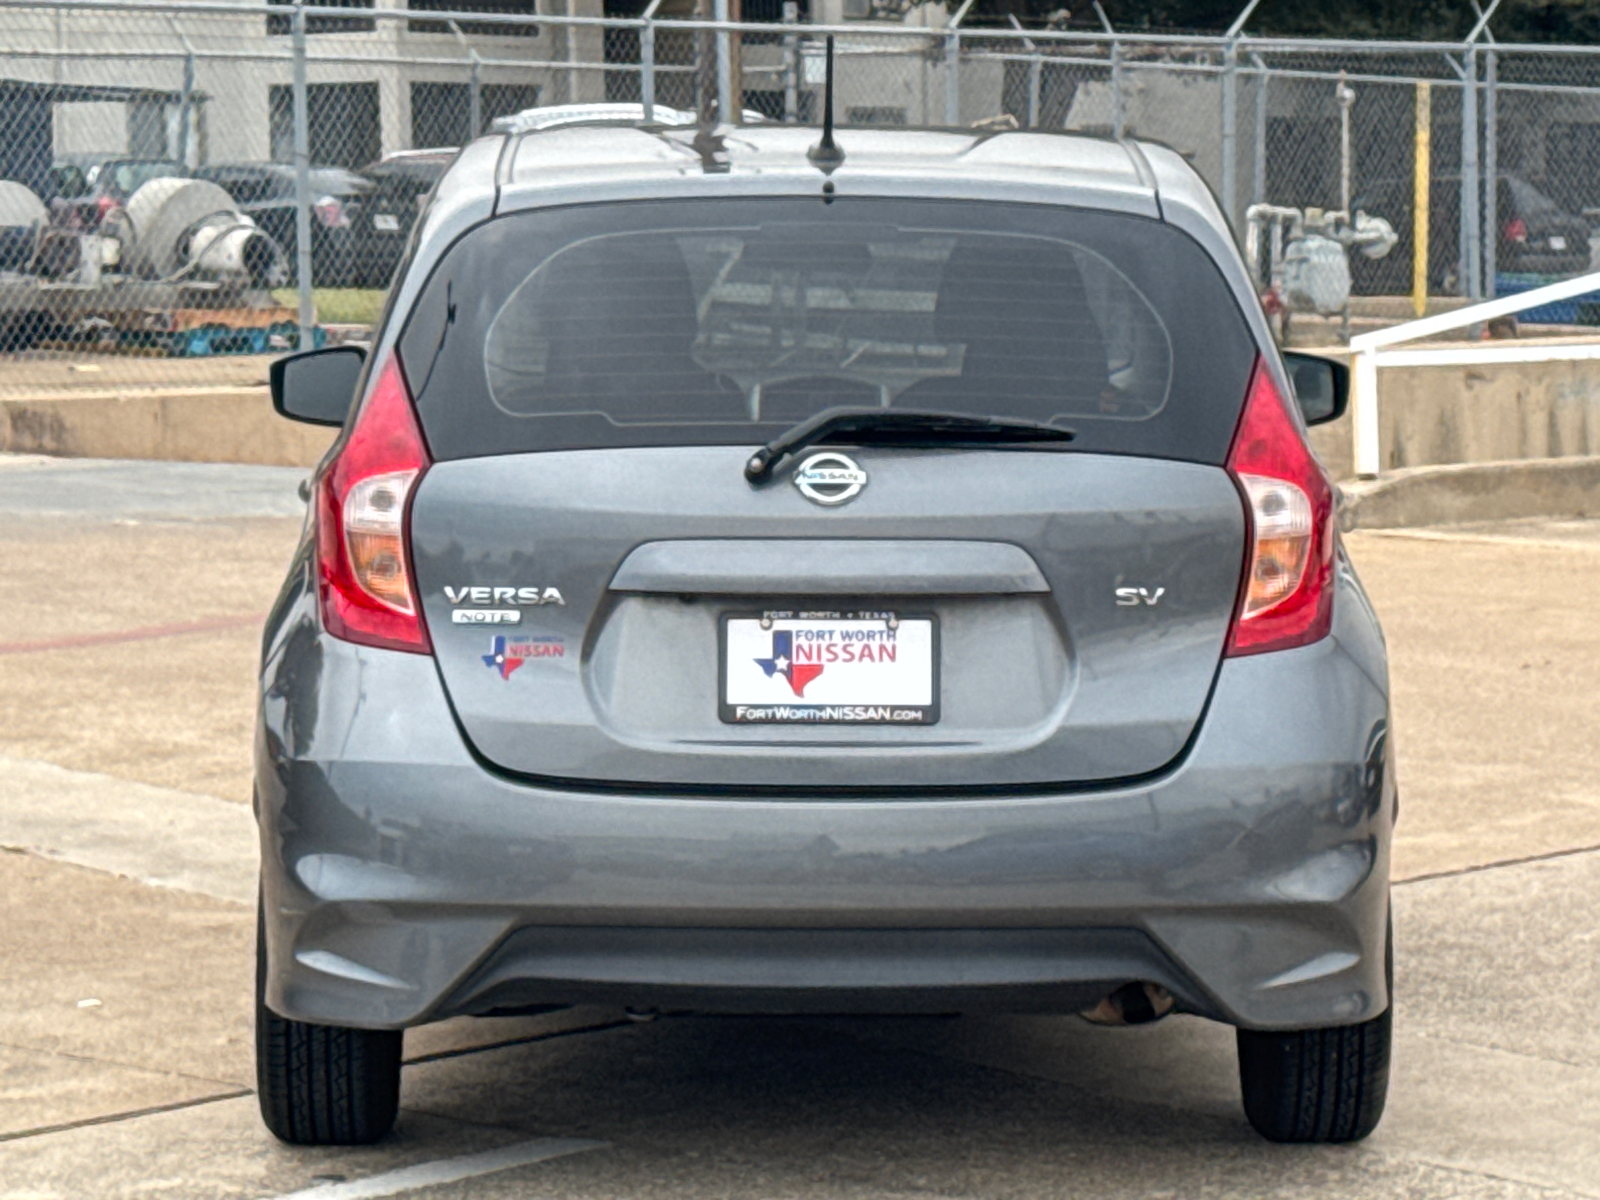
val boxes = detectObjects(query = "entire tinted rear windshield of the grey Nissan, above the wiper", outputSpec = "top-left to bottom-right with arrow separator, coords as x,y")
402,198 -> 1254,462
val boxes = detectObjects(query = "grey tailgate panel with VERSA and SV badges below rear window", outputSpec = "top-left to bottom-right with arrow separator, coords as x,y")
413,446 -> 1245,787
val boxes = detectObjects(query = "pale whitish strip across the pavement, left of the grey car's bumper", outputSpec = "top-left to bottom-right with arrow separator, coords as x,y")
0,757 -> 259,904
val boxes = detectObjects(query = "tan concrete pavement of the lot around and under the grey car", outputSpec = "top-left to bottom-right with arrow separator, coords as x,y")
0,459 -> 1600,1200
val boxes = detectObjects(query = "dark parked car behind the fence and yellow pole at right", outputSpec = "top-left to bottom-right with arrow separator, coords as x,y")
1350,174 -> 1589,296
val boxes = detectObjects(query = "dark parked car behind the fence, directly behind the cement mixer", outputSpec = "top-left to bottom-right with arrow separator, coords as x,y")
195,163 -> 374,288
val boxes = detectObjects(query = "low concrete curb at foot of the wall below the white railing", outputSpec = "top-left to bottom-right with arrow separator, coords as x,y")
1339,456 -> 1600,530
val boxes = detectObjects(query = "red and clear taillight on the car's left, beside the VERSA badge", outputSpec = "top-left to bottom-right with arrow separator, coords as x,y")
317,357 -> 434,654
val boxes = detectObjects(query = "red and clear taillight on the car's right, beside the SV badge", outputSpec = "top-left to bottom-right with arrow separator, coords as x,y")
1227,360 -> 1333,656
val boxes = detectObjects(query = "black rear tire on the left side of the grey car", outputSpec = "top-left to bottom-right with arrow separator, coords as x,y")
256,909 -> 402,1146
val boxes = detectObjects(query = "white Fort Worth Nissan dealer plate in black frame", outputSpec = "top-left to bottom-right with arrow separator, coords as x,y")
720,610 -> 939,725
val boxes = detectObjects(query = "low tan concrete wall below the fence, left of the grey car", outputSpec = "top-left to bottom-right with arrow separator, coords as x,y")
0,387 -> 334,467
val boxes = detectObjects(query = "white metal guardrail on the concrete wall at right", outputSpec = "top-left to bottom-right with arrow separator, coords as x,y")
1350,272 -> 1600,478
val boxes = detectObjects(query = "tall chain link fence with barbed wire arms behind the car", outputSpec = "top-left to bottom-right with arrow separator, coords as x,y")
0,0 -> 1600,394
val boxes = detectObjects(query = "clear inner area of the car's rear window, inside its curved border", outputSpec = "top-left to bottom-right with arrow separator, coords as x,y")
485,221 -> 1171,424
